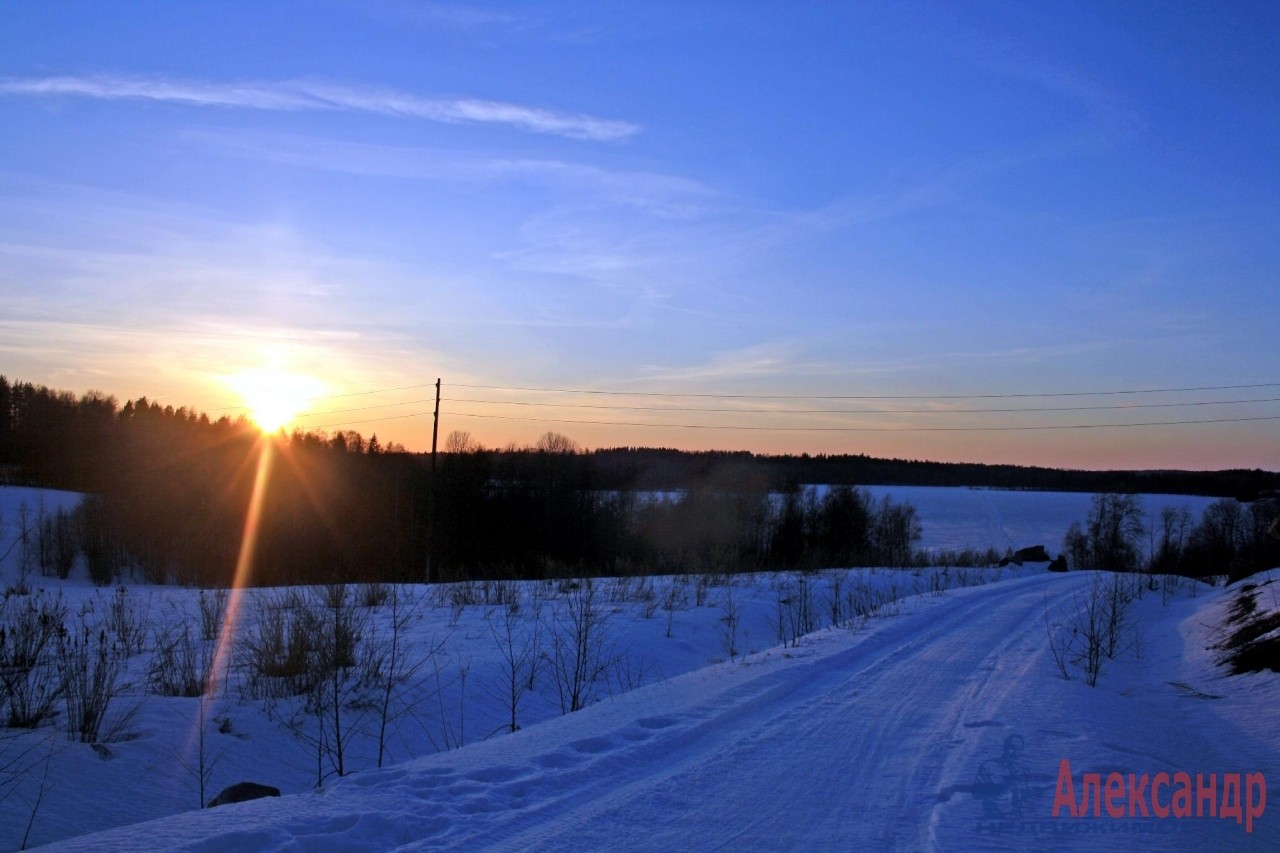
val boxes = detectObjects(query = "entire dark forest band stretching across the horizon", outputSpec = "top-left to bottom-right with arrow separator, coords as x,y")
0,377 -> 1280,587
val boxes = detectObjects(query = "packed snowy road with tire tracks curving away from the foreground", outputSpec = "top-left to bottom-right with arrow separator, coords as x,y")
442,576 -> 1085,850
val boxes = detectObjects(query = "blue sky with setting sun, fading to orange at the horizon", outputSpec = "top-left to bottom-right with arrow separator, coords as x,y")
0,0 -> 1280,470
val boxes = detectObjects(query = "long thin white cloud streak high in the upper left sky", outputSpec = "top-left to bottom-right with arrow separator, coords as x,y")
0,76 -> 640,141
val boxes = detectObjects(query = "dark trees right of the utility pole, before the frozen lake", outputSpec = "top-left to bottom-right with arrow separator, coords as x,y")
431,445 -> 920,579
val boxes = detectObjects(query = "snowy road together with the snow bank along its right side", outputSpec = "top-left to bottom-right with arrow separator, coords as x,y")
45,573 -> 1280,850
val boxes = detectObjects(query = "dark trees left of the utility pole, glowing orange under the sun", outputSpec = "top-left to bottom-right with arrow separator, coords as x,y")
0,377 -> 429,585
